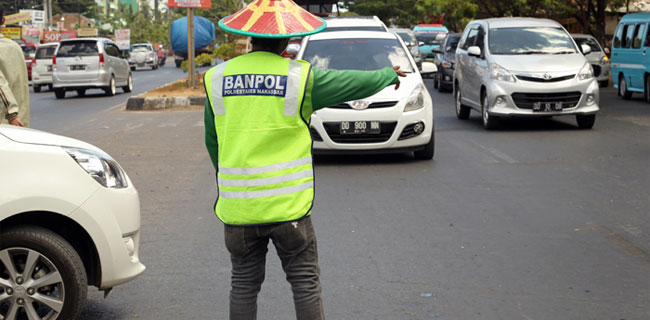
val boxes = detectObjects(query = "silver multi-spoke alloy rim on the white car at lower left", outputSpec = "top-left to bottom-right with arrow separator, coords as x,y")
0,247 -> 65,320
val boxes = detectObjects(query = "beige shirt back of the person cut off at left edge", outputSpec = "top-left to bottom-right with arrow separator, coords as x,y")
0,37 -> 29,126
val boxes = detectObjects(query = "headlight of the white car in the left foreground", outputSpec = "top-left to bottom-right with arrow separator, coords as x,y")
63,147 -> 128,189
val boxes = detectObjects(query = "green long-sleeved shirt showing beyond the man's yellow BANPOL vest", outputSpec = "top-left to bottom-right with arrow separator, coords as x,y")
204,68 -> 398,169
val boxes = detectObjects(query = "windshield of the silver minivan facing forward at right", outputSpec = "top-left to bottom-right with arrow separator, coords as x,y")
489,27 -> 577,55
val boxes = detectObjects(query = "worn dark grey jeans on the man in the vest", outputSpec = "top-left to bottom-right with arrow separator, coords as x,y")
224,216 -> 325,320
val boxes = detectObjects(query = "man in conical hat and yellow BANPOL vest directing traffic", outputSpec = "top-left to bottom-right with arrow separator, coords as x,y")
204,0 -> 405,320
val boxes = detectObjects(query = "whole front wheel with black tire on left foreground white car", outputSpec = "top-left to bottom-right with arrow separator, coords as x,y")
0,226 -> 88,320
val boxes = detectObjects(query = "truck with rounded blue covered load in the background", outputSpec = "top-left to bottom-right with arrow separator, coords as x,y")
169,16 -> 217,68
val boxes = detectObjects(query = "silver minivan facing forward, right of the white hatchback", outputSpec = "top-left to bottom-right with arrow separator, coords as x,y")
454,18 -> 599,129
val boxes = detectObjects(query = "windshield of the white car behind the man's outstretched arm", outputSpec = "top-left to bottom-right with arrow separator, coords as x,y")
302,39 -> 414,73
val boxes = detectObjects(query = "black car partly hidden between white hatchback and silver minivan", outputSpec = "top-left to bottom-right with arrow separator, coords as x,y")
433,33 -> 463,92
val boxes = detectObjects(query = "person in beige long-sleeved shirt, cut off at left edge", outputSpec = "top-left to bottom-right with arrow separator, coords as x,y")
0,4 -> 29,127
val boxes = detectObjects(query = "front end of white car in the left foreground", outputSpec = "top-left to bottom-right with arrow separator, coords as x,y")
0,125 -> 145,320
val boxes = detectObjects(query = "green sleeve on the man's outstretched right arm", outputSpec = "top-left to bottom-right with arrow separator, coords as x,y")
311,68 -> 399,111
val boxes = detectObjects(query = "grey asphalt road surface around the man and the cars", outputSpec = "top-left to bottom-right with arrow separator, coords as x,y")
32,71 -> 650,320
